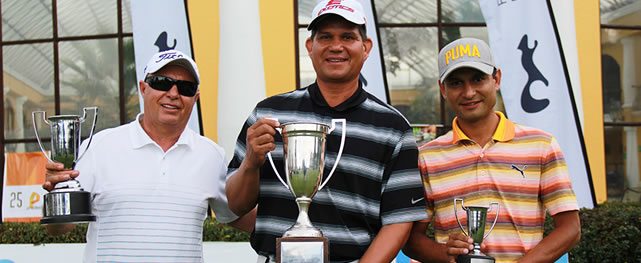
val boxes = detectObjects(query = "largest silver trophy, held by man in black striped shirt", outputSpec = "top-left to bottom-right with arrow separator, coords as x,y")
267,119 -> 345,263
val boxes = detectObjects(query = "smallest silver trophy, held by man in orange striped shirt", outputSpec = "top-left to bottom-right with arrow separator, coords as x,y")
454,198 -> 500,263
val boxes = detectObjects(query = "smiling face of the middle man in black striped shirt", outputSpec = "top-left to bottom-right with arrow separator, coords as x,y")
305,15 -> 372,83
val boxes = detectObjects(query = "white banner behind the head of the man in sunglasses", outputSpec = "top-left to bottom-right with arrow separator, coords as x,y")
131,0 -> 200,133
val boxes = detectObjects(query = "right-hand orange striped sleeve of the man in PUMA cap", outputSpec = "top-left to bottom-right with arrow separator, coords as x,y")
540,137 -> 579,215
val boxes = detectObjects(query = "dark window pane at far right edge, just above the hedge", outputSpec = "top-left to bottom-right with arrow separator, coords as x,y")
605,126 -> 641,201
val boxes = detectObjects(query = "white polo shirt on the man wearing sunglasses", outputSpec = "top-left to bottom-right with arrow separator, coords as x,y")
76,115 -> 237,262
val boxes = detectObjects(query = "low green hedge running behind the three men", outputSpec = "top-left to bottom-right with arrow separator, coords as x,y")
0,202 -> 641,262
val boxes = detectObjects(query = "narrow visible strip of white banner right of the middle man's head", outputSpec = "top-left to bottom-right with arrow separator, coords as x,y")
361,0 -> 390,103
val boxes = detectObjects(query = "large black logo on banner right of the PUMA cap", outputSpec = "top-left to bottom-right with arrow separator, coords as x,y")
518,35 -> 550,113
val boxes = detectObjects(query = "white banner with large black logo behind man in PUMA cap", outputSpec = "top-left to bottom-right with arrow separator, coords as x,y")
479,0 -> 596,208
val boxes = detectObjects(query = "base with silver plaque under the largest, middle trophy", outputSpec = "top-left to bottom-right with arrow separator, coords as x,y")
276,237 -> 329,263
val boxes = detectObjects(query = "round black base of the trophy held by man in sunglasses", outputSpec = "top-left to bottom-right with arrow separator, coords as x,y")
40,190 -> 96,224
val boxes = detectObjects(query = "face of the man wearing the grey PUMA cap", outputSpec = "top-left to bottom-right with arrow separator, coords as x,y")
439,68 -> 501,126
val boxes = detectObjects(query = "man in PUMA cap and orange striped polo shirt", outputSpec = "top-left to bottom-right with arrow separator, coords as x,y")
404,38 -> 581,262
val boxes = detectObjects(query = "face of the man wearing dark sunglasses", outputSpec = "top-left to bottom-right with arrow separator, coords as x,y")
140,65 -> 200,129
